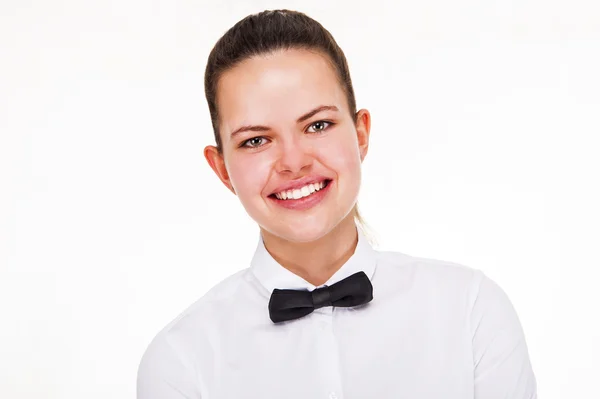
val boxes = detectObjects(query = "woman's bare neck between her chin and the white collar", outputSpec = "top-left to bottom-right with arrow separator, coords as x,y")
261,213 -> 358,286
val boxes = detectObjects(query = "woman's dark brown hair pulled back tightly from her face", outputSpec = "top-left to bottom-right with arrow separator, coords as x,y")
204,9 -> 372,241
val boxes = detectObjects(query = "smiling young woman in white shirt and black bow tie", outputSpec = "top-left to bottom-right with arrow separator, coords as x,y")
137,10 -> 537,399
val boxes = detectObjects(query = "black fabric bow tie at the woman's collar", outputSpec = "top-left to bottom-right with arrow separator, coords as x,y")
269,272 -> 373,323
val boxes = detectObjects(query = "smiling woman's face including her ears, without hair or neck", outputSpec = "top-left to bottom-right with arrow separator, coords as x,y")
205,50 -> 370,242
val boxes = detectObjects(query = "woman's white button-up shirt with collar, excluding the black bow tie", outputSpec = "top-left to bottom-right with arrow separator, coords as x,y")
137,229 -> 537,399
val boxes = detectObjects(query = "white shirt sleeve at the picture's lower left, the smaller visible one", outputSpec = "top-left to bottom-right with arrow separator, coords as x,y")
137,333 -> 201,399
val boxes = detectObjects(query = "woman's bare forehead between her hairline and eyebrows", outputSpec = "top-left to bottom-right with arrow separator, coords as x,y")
217,49 -> 347,133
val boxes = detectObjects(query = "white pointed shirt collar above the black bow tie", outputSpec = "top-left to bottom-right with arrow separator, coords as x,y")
250,228 -> 376,295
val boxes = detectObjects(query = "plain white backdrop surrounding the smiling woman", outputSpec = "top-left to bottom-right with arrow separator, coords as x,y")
0,0 -> 600,399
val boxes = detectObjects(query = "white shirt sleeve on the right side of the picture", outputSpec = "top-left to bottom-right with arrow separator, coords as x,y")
470,271 -> 537,399
